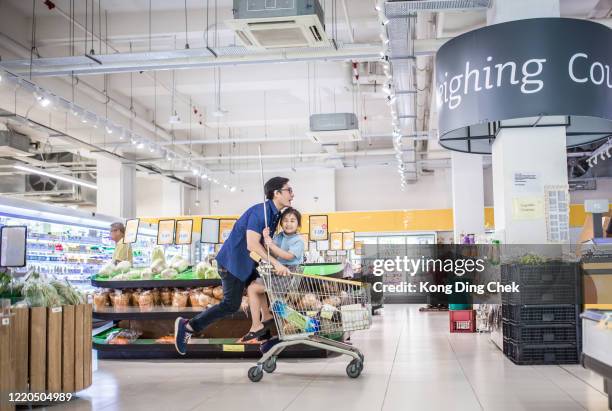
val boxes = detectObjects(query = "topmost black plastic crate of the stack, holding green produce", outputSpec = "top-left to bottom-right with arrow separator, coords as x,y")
501,261 -> 580,286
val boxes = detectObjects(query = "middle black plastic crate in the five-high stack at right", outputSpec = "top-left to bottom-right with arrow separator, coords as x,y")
502,304 -> 580,325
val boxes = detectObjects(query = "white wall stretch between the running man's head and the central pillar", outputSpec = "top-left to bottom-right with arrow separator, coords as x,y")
336,167 -> 452,211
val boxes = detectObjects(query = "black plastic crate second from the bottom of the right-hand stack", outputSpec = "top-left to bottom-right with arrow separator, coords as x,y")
503,321 -> 580,344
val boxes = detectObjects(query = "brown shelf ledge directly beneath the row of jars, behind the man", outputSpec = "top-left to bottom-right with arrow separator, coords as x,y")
93,306 -> 241,320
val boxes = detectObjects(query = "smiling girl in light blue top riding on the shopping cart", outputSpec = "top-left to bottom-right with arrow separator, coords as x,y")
242,207 -> 304,342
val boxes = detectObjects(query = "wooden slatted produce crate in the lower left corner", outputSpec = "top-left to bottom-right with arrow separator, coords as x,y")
0,304 -> 92,411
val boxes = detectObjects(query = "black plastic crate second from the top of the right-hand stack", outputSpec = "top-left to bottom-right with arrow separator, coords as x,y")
502,285 -> 580,305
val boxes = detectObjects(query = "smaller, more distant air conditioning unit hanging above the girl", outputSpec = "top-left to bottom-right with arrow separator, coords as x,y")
306,113 -> 361,144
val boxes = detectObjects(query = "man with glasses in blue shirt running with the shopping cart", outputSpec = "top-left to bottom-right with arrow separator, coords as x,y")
174,177 -> 293,355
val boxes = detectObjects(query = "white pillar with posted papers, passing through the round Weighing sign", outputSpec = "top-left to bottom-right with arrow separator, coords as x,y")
487,0 -> 569,244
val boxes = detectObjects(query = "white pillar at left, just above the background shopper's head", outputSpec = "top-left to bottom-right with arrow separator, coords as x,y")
96,156 -> 136,219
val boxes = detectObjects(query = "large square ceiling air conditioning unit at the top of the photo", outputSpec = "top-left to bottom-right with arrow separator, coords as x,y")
225,0 -> 331,49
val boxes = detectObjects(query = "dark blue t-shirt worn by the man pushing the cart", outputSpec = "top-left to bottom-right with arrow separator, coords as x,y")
216,200 -> 280,281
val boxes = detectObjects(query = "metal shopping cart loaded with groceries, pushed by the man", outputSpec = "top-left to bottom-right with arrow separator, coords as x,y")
248,265 -> 372,382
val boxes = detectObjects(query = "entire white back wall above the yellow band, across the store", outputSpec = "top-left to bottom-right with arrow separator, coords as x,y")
136,167 -> 612,217
